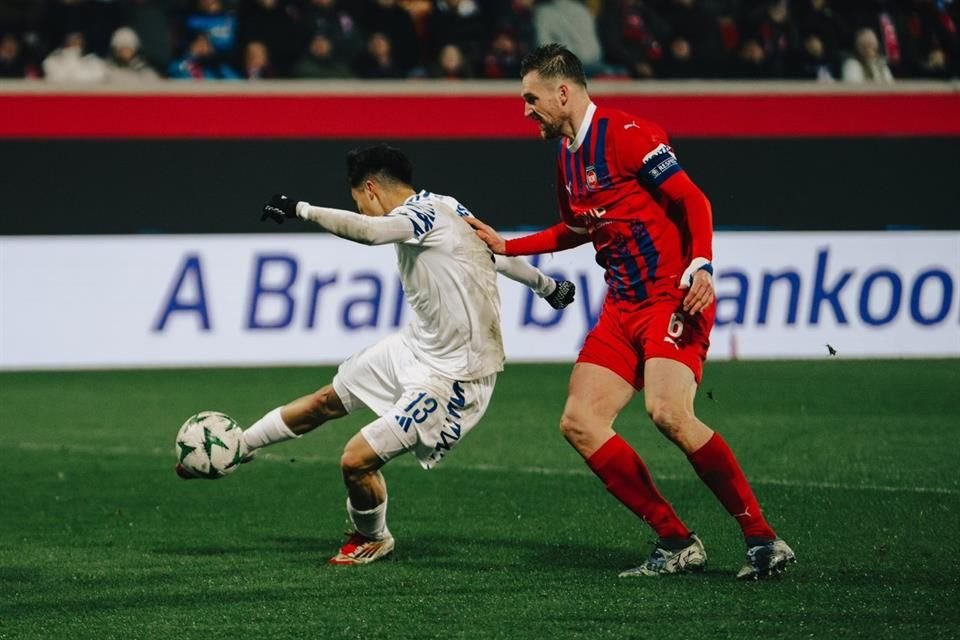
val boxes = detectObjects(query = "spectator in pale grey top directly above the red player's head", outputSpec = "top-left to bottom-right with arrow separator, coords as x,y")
533,0 -> 605,75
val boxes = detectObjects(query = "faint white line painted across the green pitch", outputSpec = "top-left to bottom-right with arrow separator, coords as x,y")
15,442 -> 960,496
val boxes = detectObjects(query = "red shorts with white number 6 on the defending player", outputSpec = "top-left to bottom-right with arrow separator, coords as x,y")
577,289 -> 717,391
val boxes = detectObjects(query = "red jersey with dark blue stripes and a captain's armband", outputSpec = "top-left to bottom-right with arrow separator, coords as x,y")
557,104 -> 712,301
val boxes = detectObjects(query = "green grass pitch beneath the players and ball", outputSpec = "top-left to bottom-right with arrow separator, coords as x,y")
0,359 -> 960,640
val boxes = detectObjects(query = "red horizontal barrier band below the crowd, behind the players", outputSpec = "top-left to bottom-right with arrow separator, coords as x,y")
0,85 -> 960,139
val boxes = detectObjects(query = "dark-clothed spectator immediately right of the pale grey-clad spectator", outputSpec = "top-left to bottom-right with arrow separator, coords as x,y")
596,0 -> 665,78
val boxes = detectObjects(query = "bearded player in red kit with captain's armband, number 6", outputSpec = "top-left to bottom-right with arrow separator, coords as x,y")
469,44 -> 795,578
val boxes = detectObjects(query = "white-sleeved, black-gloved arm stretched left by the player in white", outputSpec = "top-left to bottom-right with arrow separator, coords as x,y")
260,195 -> 414,245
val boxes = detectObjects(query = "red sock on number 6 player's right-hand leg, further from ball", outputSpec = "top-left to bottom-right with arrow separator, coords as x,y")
688,433 -> 776,538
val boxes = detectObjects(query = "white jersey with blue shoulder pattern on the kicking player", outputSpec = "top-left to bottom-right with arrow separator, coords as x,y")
387,191 -> 504,380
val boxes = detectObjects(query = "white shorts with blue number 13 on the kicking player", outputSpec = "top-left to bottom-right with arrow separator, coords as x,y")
333,334 -> 497,469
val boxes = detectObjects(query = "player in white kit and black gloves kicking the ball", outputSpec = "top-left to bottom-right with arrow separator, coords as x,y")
178,145 -> 574,564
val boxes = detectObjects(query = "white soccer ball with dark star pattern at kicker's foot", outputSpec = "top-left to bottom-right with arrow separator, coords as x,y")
176,411 -> 243,479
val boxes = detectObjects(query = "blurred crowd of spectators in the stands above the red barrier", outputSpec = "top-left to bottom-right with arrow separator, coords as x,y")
0,0 -> 960,83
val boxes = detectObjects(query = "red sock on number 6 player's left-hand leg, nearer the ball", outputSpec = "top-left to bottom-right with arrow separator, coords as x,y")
587,434 -> 690,538
